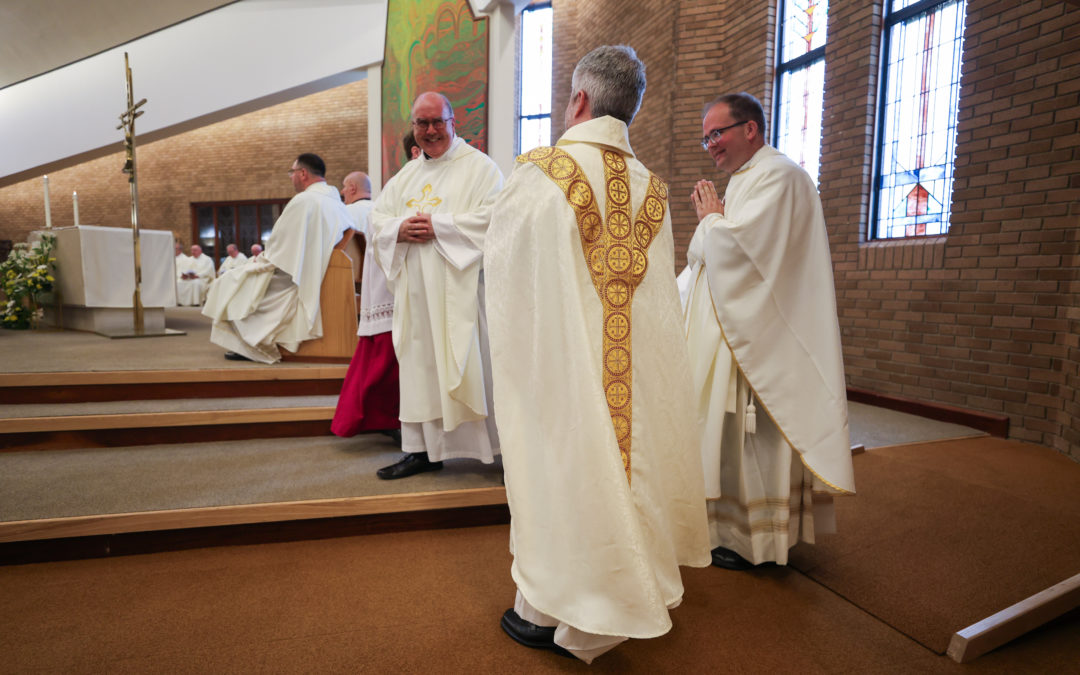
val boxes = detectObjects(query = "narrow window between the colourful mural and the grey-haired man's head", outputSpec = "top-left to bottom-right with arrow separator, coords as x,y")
517,4 -> 552,152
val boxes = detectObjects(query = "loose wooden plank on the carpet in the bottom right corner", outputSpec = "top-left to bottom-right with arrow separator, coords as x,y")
946,573 -> 1080,663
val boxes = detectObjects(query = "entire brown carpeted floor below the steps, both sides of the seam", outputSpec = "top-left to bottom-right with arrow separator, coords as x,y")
0,438 -> 1080,673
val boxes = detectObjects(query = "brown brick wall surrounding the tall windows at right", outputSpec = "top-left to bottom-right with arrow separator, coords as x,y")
553,0 -> 1080,460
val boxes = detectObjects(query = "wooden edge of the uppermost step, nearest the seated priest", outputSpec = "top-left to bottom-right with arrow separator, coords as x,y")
0,365 -> 349,388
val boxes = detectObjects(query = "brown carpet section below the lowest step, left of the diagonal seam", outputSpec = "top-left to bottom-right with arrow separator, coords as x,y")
0,526 -> 1080,673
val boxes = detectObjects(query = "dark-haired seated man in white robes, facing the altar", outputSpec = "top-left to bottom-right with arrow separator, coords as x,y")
203,152 -> 352,363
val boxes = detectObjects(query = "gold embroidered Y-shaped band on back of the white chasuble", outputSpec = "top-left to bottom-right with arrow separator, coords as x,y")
517,148 -> 667,483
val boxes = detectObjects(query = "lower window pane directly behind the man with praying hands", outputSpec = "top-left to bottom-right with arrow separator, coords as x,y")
777,59 -> 825,184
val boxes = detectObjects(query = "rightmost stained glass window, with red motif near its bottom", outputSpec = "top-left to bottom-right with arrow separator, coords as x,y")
874,0 -> 967,239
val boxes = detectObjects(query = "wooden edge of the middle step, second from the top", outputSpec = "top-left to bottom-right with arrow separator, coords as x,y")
0,406 -> 335,432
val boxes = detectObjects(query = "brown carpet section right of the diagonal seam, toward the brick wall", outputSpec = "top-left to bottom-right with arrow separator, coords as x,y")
791,437 -> 1080,652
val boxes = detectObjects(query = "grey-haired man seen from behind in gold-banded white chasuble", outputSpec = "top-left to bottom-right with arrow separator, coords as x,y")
484,46 -> 710,661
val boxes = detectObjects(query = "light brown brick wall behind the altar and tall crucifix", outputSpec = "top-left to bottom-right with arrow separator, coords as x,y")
0,81 -> 367,245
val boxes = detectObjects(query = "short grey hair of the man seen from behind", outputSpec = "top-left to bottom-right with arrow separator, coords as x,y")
570,44 -> 645,126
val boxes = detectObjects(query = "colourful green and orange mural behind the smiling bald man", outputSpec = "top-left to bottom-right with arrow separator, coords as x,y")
382,0 -> 488,181
